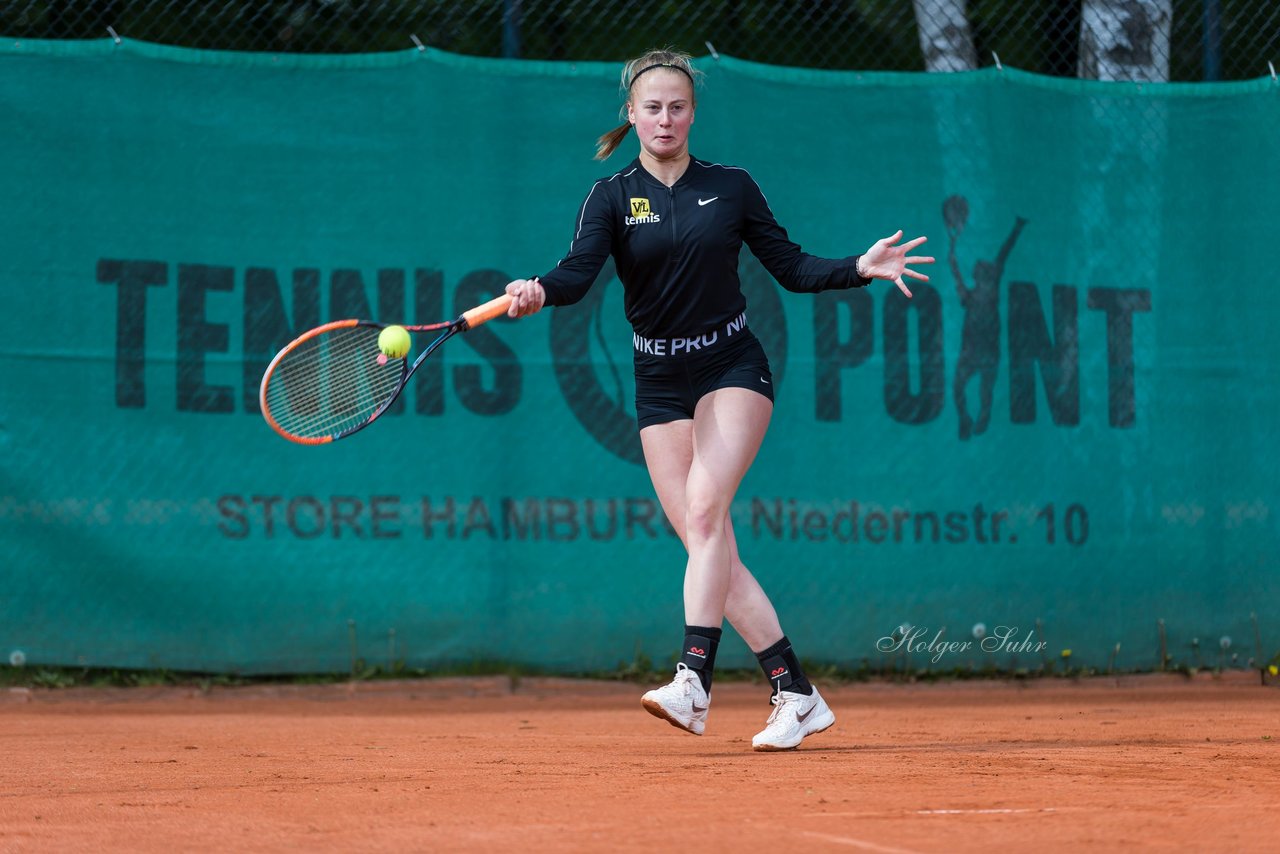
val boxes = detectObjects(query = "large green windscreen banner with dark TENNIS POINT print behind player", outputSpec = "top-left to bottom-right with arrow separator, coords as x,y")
0,40 -> 1280,673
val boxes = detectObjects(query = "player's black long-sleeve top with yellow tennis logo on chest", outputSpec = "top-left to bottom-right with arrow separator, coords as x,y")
540,159 -> 870,338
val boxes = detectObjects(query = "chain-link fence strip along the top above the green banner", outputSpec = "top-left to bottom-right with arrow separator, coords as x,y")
0,0 -> 1280,81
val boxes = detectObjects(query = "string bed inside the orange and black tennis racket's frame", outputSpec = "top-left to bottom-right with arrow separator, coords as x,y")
259,326 -> 404,438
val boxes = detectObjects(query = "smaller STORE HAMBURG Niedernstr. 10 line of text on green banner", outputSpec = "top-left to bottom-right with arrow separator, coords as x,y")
215,494 -> 1089,547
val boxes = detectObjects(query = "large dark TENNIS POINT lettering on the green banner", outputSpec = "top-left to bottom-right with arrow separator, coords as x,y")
95,257 -> 1152,435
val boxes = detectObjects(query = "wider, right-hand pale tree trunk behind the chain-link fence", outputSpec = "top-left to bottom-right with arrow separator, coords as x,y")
1079,0 -> 1174,83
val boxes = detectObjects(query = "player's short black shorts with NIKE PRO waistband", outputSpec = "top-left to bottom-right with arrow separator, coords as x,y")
635,329 -> 773,430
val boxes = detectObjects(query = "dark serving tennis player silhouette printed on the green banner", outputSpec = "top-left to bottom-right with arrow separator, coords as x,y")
942,196 -> 1027,440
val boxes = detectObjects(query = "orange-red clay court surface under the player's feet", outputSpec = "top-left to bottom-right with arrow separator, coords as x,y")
0,673 -> 1280,854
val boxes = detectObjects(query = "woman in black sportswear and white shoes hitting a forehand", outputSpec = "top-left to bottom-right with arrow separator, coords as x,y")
507,50 -> 933,750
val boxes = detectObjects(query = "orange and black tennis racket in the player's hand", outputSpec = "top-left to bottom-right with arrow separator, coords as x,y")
257,294 -> 511,444
